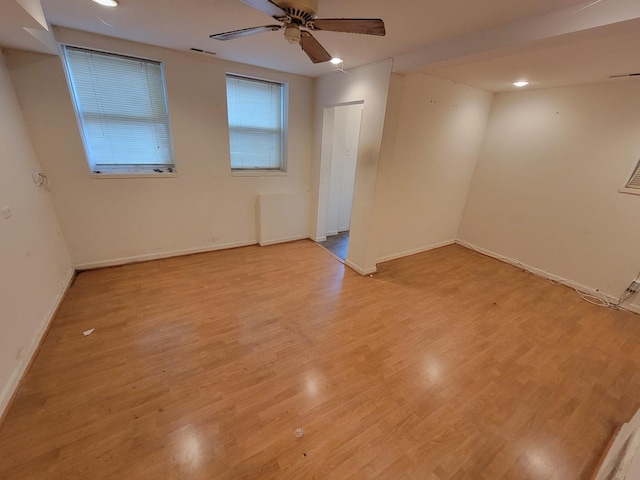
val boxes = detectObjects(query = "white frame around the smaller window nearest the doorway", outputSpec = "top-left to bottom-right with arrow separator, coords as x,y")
225,72 -> 289,177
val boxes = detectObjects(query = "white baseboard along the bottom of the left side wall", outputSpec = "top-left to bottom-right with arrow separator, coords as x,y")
0,268 -> 76,426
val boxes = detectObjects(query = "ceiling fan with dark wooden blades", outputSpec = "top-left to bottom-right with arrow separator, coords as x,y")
210,0 -> 386,63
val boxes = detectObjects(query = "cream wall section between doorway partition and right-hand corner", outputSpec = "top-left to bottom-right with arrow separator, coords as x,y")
373,74 -> 493,262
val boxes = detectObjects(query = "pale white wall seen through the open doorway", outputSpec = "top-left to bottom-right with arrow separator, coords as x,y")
327,104 -> 362,235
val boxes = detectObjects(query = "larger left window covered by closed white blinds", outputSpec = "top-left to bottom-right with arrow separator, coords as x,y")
63,46 -> 175,174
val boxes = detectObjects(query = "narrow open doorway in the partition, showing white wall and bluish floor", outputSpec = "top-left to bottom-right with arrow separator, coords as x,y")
320,102 -> 363,262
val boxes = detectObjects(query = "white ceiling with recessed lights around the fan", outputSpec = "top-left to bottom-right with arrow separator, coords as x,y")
0,0 -> 640,92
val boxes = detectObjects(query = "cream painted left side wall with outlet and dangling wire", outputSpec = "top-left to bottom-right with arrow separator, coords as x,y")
0,47 -> 73,415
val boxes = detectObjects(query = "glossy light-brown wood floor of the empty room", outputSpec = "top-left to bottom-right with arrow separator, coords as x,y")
0,241 -> 640,480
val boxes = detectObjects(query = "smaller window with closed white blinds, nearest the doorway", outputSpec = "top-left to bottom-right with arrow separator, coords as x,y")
227,74 -> 287,171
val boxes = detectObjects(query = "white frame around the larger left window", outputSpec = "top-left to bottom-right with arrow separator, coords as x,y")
59,43 -> 178,178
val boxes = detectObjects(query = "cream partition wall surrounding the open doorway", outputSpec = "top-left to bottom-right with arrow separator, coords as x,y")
311,59 -> 393,274
